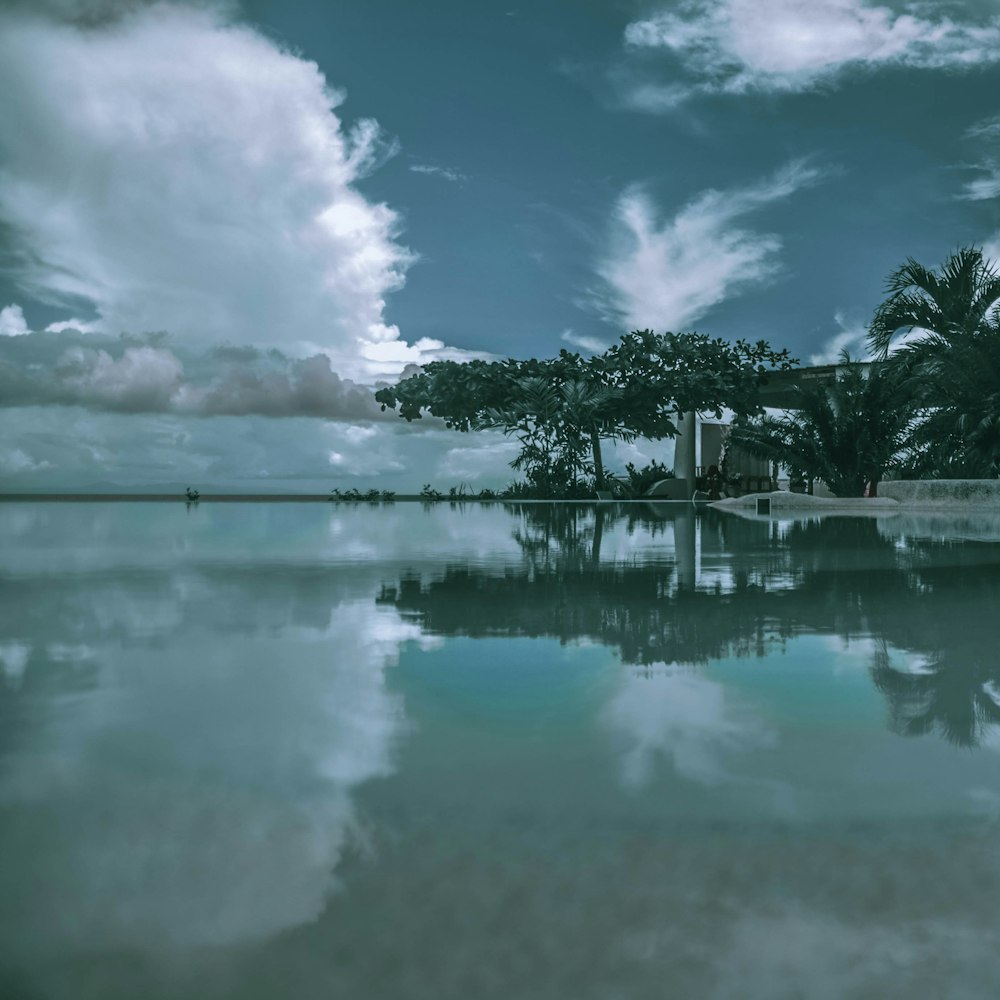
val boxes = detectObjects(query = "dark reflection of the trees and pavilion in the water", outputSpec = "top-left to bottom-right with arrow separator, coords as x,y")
380,505 -> 1000,746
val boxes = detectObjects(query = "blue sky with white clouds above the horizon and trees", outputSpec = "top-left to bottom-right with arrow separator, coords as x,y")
0,0 -> 1000,492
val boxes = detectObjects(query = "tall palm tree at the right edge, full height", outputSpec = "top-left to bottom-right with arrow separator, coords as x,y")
869,247 -> 1000,477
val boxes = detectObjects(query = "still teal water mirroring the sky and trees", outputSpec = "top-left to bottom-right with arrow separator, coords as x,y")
0,503 -> 1000,1000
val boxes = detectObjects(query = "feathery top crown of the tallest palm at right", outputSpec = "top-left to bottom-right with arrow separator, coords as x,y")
868,247 -> 1000,358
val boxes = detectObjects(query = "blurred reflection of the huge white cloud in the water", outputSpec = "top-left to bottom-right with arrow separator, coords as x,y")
0,592 -> 420,954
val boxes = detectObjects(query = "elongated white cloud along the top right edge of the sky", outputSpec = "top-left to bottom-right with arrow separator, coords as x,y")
625,0 -> 1000,98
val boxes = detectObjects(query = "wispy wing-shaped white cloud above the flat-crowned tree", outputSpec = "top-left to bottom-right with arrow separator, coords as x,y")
597,161 -> 821,330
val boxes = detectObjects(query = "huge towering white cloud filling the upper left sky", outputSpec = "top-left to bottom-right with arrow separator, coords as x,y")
0,3 -> 414,372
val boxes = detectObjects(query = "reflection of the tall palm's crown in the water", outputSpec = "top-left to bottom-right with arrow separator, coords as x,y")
871,644 -> 1000,747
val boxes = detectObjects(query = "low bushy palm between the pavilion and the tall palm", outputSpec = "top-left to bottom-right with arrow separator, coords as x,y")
730,351 -> 915,497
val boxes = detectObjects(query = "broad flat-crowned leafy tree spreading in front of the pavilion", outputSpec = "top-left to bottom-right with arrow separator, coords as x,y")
375,330 -> 794,495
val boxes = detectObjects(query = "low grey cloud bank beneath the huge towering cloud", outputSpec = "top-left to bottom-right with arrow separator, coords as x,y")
0,332 -> 391,421
